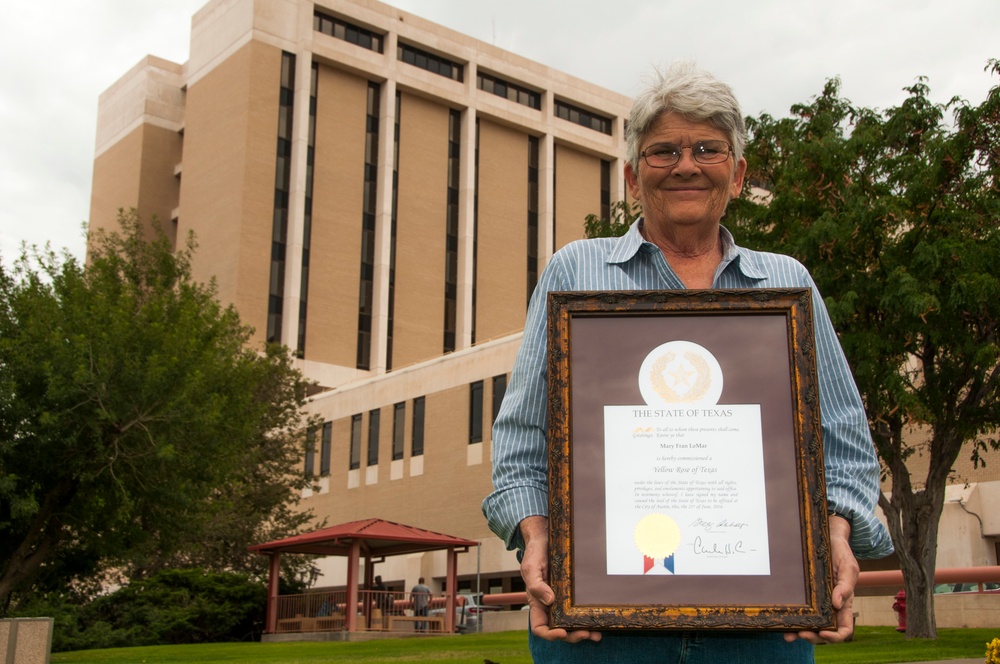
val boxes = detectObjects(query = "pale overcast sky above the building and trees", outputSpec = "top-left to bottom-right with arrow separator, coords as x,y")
0,0 -> 1000,263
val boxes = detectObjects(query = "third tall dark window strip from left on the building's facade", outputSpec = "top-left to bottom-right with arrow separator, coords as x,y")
357,81 -> 381,370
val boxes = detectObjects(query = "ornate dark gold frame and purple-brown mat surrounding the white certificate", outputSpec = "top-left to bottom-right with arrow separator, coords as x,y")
548,289 -> 836,631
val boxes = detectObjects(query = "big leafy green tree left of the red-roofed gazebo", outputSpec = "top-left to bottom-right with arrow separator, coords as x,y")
0,212 -> 310,611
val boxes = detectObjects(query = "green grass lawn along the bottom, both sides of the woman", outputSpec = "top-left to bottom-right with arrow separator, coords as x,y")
52,627 -> 1000,664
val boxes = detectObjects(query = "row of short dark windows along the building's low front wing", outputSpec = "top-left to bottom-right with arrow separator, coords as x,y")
305,374 -> 507,478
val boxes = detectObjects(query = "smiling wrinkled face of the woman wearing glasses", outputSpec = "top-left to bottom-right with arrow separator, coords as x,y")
625,113 -> 747,229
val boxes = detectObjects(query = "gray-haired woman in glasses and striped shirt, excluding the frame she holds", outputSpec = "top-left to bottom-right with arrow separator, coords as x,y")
483,64 -> 892,664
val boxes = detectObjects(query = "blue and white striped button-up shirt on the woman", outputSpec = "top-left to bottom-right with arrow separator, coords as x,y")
483,220 -> 892,558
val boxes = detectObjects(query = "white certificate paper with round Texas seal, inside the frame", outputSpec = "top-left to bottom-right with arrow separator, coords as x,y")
604,341 -> 770,576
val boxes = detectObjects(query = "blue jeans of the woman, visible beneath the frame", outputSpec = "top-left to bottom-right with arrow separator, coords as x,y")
528,632 -> 815,664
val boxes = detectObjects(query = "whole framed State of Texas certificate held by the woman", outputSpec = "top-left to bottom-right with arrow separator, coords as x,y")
548,289 -> 836,631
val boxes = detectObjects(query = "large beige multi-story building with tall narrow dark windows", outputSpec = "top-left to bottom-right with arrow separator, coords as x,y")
90,0 -> 1000,608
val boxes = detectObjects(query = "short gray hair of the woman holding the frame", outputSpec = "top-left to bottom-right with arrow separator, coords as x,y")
625,62 -> 747,172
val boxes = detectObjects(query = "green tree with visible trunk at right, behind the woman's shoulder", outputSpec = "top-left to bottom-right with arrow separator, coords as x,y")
729,61 -> 1000,638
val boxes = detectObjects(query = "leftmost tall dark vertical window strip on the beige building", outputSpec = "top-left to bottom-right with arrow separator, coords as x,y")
267,53 -> 295,343
